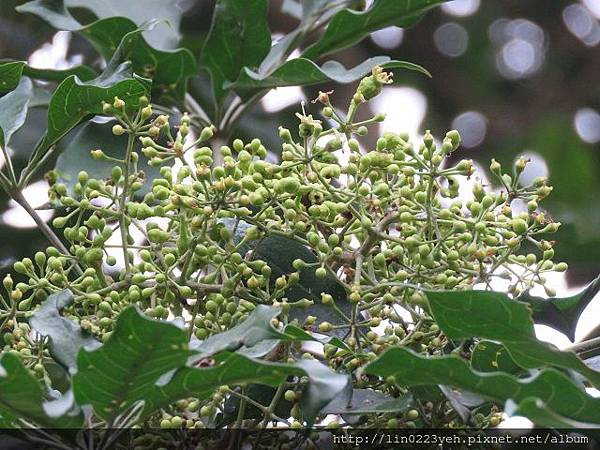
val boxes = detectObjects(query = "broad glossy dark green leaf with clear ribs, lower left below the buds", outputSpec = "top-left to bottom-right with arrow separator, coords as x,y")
73,306 -> 193,425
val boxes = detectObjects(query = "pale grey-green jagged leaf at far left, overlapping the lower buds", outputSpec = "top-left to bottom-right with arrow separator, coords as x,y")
29,289 -> 100,371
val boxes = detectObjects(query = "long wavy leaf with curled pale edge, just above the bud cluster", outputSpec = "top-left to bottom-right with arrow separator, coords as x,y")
226,56 -> 429,90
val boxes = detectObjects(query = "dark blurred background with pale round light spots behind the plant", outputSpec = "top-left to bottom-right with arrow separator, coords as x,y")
0,0 -> 600,285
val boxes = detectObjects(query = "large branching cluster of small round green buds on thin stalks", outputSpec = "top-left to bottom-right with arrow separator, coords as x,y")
1,68 -> 566,427
